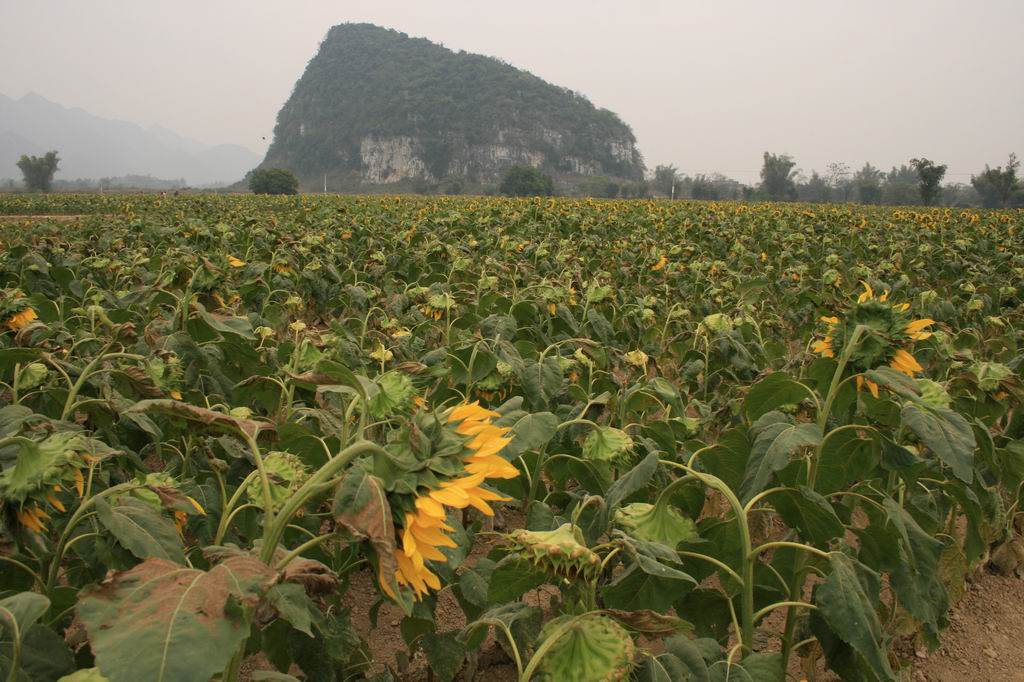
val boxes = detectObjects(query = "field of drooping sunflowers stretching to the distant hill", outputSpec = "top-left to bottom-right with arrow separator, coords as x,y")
0,195 -> 1024,682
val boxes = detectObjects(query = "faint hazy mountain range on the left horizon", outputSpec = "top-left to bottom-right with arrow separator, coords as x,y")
0,93 -> 261,185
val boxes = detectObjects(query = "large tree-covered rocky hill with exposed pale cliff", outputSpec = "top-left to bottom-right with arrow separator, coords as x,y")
262,25 -> 643,185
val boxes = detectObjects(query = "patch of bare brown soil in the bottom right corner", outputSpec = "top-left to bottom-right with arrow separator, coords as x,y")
912,573 -> 1024,682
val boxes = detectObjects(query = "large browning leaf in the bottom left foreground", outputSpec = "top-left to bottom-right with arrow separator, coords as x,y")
78,556 -> 274,682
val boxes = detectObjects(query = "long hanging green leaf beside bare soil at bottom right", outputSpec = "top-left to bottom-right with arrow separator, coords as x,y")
814,552 -> 896,682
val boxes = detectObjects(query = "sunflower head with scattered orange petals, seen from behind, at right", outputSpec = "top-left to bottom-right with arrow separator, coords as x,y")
813,282 -> 935,397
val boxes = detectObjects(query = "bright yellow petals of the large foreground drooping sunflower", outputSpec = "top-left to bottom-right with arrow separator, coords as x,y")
380,402 -> 519,599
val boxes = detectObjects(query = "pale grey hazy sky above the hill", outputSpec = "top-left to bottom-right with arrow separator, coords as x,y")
0,0 -> 1024,181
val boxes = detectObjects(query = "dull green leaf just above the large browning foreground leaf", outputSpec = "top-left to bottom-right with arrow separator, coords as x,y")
95,498 -> 185,563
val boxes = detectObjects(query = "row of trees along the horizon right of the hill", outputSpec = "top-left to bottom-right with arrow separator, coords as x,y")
651,152 -> 1024,208
